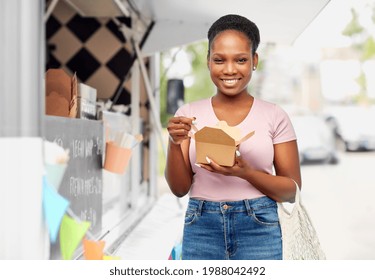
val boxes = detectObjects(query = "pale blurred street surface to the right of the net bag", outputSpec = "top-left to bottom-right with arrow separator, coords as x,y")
301,151 -> 375,260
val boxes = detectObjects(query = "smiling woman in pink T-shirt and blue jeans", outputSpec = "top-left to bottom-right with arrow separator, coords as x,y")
165,15 -> 301,260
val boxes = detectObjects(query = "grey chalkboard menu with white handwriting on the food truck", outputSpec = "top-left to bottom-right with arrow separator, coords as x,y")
45,116 -> 104,255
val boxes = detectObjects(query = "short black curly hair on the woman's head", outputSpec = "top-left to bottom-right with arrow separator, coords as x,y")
207,14 -> 260,55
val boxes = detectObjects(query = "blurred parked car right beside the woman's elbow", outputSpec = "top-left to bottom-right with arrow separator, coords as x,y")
291,114 -> 339,164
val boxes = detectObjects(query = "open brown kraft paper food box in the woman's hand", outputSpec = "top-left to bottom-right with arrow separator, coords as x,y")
192,121 -> 255,166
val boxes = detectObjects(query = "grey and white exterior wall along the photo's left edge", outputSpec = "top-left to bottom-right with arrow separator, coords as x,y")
0,0 -> 49,259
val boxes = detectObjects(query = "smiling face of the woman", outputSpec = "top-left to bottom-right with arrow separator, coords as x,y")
208,30 -> 258,96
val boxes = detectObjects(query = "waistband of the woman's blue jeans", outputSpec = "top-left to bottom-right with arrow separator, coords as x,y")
188,196 -> 277,215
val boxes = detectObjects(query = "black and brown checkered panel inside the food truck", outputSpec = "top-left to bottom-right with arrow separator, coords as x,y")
46,1 -> 132,105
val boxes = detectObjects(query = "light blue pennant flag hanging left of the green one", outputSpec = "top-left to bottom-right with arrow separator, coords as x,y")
43,177 -> 69,243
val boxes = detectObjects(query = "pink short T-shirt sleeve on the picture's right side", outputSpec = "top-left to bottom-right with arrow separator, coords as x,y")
272,105 -> 296,144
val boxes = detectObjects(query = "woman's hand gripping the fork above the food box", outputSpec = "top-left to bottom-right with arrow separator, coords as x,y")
167,117 -> 195,145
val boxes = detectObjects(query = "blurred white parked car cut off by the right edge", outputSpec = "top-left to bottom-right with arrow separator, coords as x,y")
326,106 -> 375,151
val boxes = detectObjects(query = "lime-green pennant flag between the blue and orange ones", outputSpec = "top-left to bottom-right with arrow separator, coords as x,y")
60,215 -> 91,260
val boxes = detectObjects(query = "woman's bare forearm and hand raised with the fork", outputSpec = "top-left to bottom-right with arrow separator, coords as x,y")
164,117 -> 193,197
